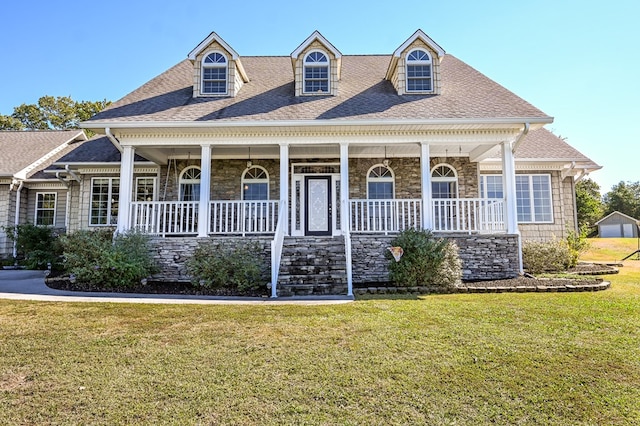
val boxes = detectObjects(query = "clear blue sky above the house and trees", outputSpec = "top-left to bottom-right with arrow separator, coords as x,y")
0,0 -> 640,194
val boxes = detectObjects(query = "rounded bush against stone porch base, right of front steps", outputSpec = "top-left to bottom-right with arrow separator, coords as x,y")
386,229 -> 462,287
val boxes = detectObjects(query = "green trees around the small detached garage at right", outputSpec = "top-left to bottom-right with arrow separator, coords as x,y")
576,178 -> 640,234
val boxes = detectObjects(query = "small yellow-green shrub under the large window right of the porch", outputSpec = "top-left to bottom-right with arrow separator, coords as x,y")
522,240 -> 577,274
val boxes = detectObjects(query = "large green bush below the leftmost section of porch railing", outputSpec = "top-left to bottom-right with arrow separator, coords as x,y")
61,230 -> 157,289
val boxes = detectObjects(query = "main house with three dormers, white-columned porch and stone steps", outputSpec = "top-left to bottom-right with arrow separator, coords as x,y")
40,30 -> 600,296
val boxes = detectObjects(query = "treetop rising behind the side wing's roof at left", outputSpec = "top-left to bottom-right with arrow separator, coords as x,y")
0,96 -> 111,130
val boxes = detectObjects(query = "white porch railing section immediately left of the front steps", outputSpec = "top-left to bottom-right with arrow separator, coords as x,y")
209,200 -> 278,235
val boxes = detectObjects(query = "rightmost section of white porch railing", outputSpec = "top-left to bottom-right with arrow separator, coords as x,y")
431,198 -> 506,233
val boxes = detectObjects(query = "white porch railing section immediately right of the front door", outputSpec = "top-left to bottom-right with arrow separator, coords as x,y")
350,199 -> 422,233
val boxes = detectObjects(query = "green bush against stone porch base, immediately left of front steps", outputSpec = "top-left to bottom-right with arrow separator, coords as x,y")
186,243 -> 268,293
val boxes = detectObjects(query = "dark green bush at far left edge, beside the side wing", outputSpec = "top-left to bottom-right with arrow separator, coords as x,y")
3,223 -> 62,269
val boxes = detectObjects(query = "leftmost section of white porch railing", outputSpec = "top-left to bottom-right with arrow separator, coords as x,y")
131,201 -> 198,236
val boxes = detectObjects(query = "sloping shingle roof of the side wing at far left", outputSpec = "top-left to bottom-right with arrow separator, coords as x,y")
0,130 -> 86,177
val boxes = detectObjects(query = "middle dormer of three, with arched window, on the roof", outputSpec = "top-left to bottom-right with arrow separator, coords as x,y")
291,31 -> 342,96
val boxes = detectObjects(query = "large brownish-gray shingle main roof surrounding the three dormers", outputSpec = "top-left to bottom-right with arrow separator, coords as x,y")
86,55 -> 547,127
